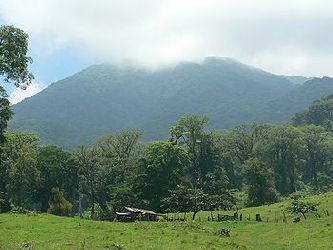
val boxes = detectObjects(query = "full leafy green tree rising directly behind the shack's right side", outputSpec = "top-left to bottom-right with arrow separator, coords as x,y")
136,141 -> 190,211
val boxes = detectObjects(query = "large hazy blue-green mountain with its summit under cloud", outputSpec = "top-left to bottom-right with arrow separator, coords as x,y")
9,57 -> 333,149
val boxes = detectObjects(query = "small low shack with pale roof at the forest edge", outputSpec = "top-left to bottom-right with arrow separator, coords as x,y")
116,207 -> 159,222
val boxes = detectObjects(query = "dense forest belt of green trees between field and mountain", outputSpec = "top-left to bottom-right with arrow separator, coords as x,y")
0,95 -> 333,219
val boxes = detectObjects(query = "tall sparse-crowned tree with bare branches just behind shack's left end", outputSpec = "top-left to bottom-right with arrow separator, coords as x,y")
93,130 -> 143,213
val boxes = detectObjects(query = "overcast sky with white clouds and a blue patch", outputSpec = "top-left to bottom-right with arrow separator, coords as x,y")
0,0 -> 333,102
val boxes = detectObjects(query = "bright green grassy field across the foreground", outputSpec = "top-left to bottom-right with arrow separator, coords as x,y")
0,192 -> 333,250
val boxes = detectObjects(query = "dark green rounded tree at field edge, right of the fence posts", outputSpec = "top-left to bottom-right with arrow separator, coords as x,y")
244,159 -> 277,206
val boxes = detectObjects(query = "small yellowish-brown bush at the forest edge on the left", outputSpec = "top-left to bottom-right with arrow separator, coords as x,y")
47,188 -> 73,216
